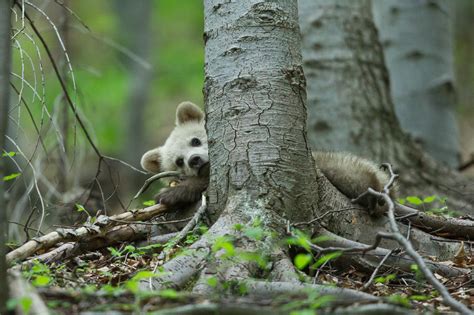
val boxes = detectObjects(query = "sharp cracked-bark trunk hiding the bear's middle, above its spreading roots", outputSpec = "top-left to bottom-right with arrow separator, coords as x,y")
204,0 -> 317,220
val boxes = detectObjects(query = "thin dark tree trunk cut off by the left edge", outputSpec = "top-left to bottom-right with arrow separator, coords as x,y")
0,0 -> 12,314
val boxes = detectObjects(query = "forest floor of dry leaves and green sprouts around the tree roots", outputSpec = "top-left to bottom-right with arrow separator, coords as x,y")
9,211 -> 474,314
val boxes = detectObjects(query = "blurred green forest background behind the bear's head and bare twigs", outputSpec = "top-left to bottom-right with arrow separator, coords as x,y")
5,0 -> 474,236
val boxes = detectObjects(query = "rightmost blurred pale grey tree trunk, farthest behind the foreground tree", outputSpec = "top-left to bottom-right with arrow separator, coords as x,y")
372,0 -> 460,168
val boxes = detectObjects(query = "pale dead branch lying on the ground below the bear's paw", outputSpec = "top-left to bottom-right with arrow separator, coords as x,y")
7,205 -> 167,264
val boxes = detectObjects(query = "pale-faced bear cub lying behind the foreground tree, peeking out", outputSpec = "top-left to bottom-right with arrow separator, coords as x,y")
141,102 -> 395,214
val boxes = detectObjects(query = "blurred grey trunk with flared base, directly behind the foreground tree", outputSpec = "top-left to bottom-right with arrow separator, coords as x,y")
299,0 -> 474,214
